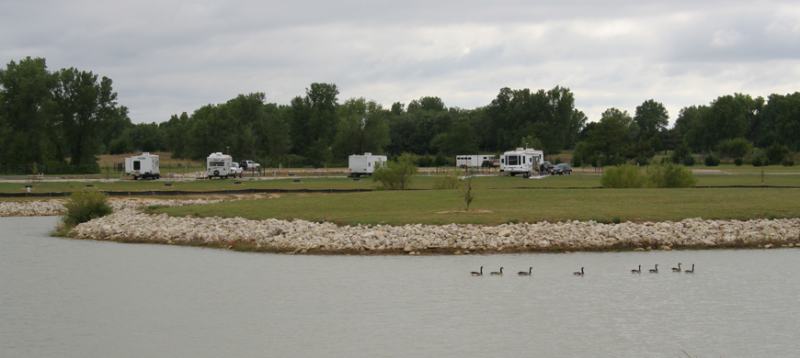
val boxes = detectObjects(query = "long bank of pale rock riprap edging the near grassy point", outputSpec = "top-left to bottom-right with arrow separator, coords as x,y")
73,210 -> 800,252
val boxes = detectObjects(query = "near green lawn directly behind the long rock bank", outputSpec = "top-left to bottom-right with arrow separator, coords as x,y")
155,189 -> 800,225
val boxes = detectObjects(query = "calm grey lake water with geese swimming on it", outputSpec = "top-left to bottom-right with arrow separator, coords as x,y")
0,218 -> 800,358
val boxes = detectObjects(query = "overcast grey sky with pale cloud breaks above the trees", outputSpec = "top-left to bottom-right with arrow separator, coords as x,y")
0,0 -> 800,123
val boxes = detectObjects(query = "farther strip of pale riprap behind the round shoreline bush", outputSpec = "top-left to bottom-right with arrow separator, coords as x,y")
0,199 -> 231,217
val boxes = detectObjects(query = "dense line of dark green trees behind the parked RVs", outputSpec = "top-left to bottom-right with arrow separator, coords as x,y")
0,57 -> 800,173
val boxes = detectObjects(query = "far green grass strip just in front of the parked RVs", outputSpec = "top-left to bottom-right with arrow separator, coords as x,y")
0,173 -> 800,193
